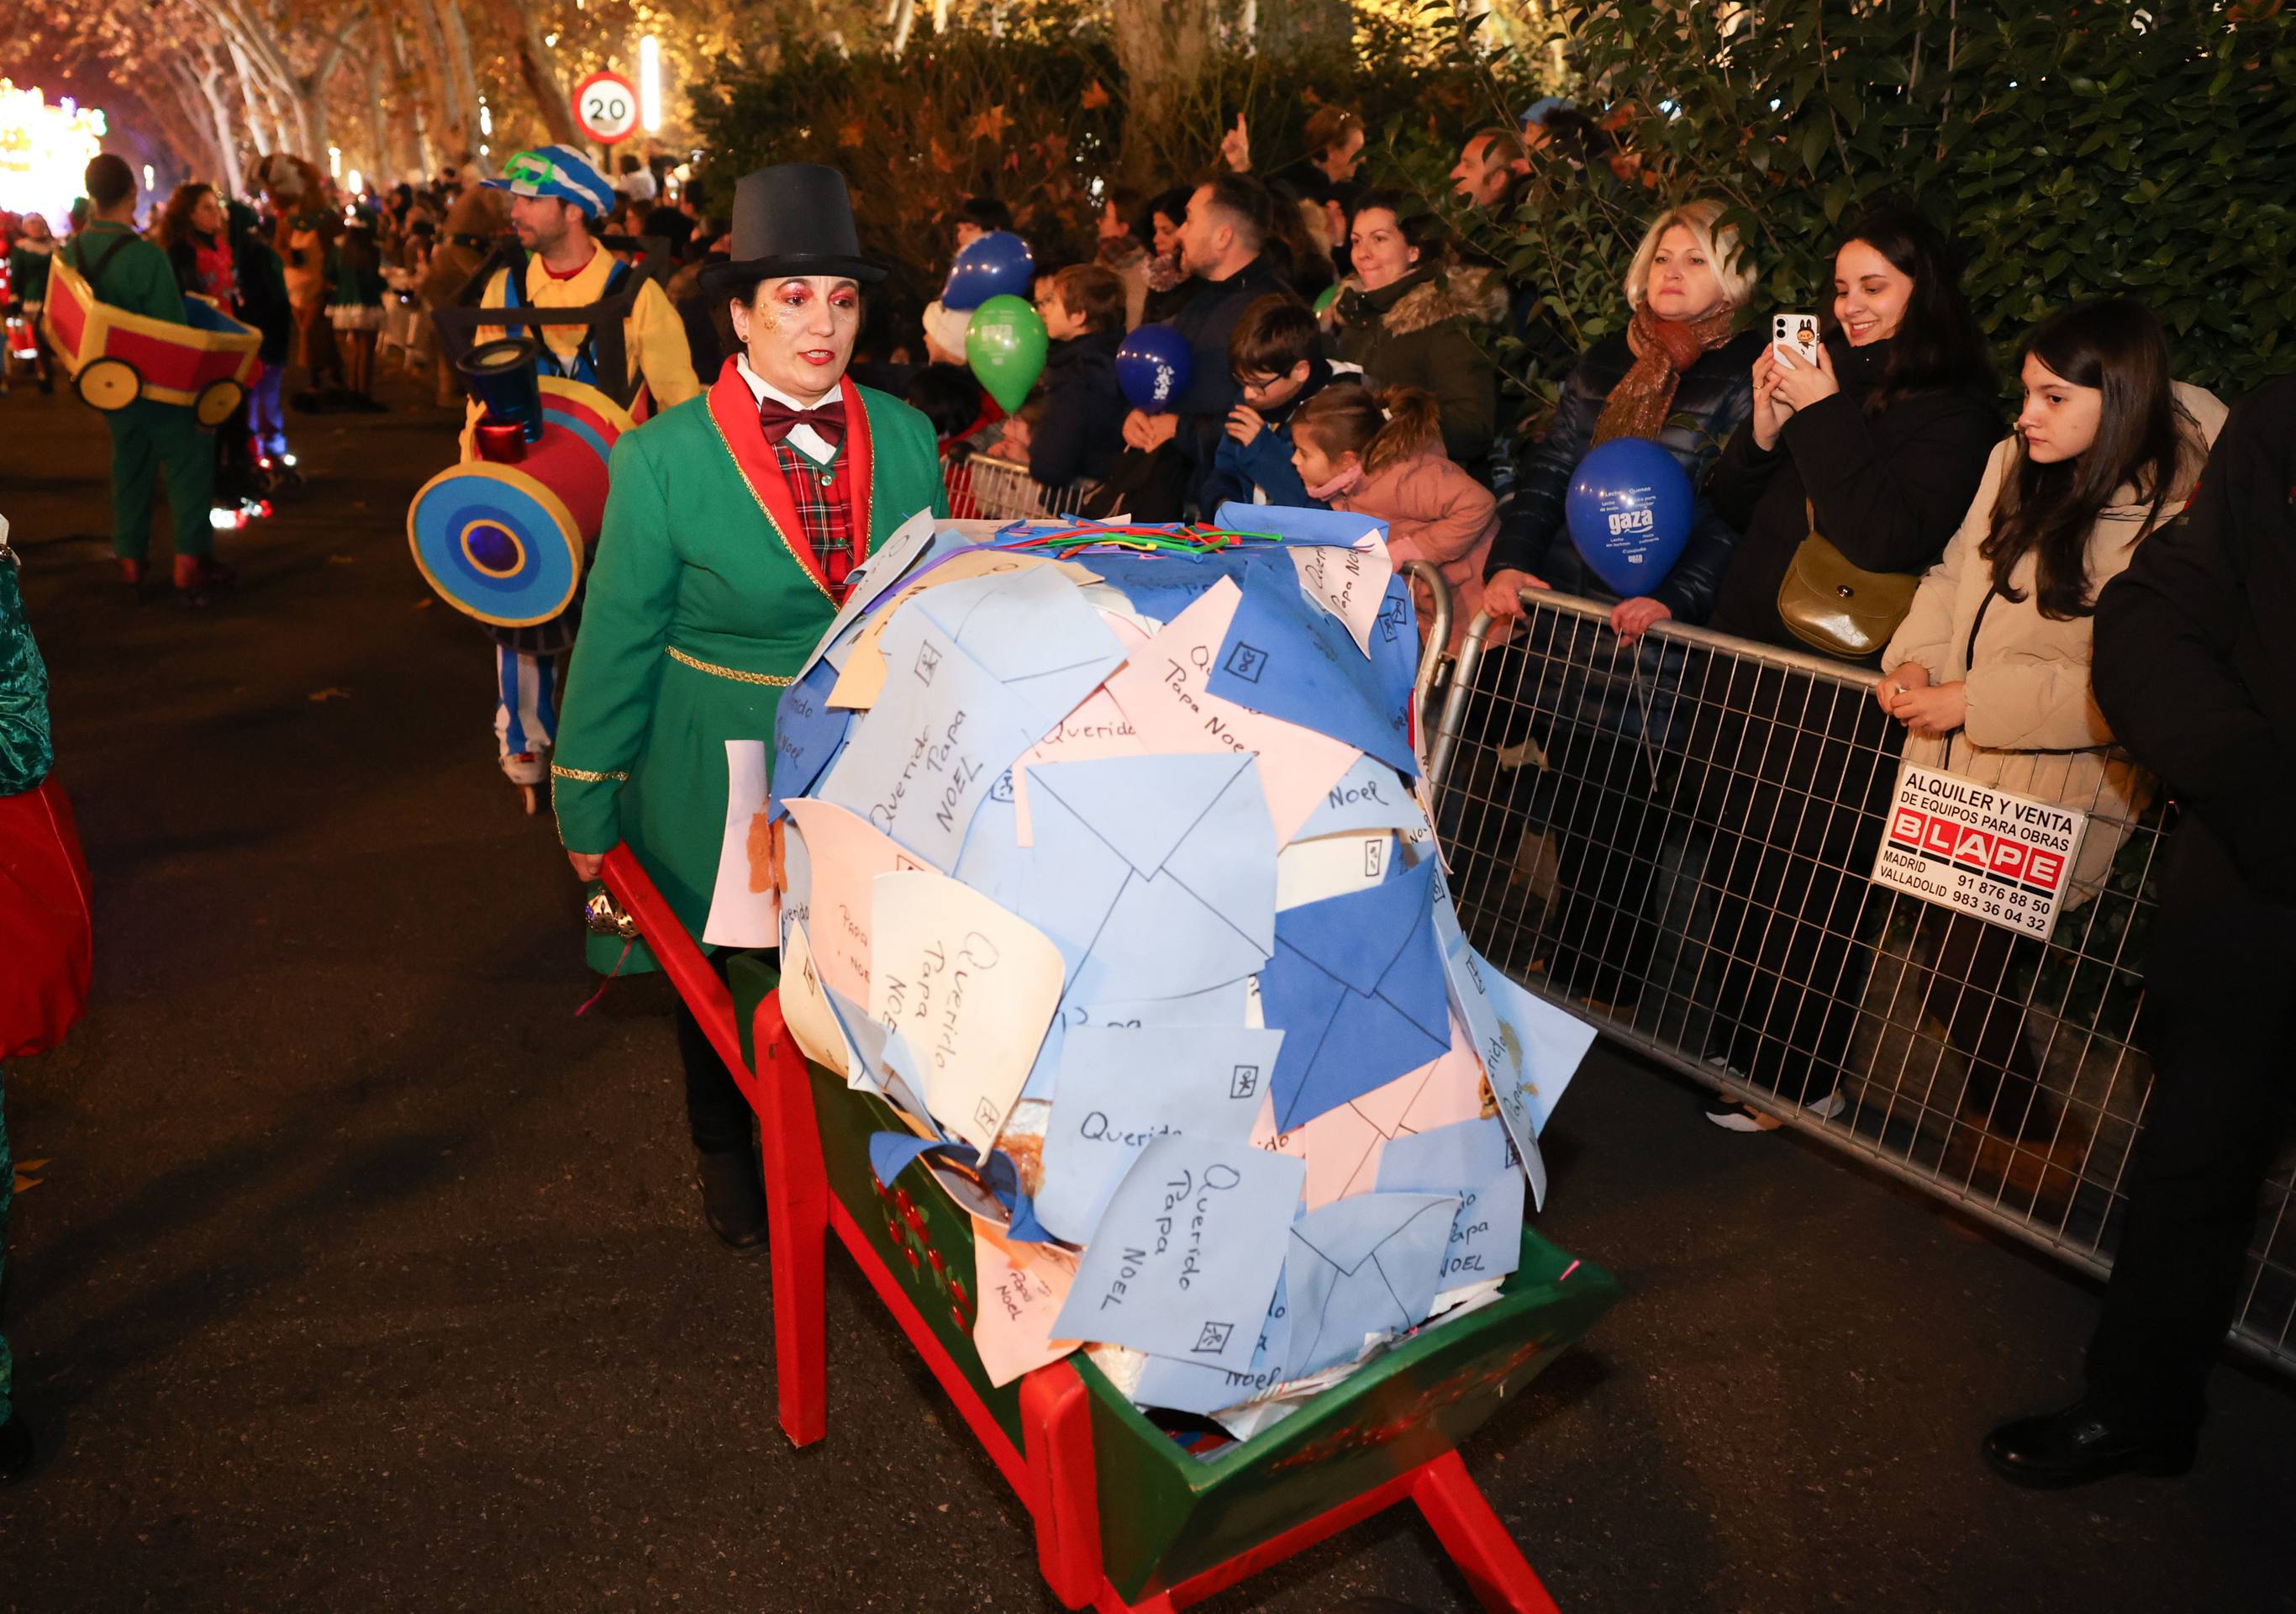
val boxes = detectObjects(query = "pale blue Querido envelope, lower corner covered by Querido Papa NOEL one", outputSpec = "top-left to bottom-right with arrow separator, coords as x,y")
1038,1024 -> 1283,1244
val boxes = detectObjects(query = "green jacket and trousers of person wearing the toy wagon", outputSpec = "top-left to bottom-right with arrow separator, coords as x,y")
64,223 -> 216,560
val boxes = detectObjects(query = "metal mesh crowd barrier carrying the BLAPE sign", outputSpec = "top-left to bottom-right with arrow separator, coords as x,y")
1428,590 -> 2296,1370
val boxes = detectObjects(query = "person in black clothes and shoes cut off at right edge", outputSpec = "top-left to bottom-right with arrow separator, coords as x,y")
1983,377 -> 2296,1485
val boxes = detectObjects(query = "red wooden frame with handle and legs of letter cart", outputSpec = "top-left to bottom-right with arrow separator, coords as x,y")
604,845 -> 1559,1614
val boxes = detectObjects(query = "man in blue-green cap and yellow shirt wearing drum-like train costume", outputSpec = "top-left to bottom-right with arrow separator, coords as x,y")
466,145 -> 703,813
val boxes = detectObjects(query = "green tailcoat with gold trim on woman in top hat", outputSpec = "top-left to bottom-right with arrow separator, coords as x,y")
551,379 -> 948,971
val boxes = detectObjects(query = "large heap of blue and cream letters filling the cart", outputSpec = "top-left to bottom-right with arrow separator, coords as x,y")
769,508 -> 1591,1437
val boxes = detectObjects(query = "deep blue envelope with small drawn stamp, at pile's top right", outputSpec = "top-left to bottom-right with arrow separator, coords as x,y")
1205,556 -> 1419,778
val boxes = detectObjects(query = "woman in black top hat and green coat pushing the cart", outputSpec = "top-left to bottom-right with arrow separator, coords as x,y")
551,163 -> 948,1249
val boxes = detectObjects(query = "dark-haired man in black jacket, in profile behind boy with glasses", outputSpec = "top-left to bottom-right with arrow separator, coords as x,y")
1125,175 -> 1290,514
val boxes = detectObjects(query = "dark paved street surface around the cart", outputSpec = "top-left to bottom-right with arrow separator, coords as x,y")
0,369 -> 2296,1614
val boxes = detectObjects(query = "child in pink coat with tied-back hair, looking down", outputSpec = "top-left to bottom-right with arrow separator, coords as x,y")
1293,381 -> 1499,654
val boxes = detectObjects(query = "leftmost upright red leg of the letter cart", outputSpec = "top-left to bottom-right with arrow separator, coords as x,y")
753,999 -> 829,1447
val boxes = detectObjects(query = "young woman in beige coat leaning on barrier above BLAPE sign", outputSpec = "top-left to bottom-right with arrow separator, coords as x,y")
1873,301 -> 2225,1139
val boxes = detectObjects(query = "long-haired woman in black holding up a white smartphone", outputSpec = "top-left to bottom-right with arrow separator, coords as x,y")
1690,204 -> 2000,1130
